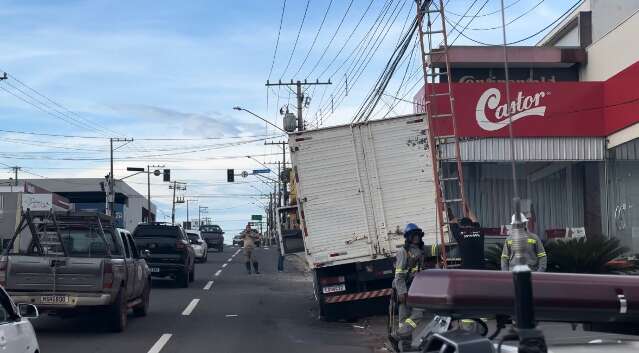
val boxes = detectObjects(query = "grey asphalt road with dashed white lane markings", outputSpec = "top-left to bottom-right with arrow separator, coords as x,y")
34,247 -> 380,353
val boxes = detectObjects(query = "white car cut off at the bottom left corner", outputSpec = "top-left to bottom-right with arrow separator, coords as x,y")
0,286 -> 40,353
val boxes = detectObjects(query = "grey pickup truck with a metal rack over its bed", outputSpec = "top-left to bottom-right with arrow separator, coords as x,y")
0,211 -> 151,332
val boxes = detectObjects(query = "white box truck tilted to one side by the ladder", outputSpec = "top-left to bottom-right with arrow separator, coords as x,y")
289,115 -> 437,319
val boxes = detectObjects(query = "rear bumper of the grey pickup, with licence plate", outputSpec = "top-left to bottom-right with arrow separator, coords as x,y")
9,292 -> 113,310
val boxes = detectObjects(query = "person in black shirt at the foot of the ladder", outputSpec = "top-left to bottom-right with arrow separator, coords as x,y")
448,209 -> 486,270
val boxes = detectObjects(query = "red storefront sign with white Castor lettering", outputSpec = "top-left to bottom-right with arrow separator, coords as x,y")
415,82 -> 605,137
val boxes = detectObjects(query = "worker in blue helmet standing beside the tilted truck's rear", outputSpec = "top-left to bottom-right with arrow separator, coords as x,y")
393,223 -> 424,338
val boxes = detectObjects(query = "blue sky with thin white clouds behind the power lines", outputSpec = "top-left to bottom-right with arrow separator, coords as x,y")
0,0 -> 574,236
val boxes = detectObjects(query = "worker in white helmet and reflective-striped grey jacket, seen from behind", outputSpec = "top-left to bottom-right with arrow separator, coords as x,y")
501,214 -> 548,272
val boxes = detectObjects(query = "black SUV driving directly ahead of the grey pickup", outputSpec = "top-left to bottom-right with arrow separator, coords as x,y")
133,223 -> 195,288
